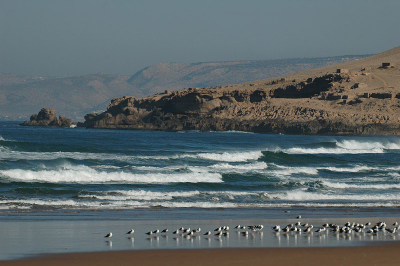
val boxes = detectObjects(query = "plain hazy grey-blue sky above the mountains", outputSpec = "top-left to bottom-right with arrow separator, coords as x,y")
0,0 -> 400,76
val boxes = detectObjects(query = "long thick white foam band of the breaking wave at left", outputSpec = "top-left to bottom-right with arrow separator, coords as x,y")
0,166 -> 223,184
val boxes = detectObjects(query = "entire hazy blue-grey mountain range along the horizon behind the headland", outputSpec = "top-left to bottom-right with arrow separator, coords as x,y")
0,55 -> 368,121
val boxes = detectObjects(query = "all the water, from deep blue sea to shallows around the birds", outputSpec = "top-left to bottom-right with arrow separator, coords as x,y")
0,122 -> 400,260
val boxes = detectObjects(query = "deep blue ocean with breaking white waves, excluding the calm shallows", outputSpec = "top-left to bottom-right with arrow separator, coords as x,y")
0,122 -> 400,218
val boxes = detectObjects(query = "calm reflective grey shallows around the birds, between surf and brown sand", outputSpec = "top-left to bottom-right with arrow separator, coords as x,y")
0,209 -> 400,260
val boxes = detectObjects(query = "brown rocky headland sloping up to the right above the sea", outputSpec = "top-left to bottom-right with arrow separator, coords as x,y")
78,47 -> 400,135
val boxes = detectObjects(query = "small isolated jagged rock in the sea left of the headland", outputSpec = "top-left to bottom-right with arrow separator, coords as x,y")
21,108 -> 72,127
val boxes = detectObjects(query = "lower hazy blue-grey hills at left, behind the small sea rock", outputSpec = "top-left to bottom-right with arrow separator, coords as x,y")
0,73 -> 138,120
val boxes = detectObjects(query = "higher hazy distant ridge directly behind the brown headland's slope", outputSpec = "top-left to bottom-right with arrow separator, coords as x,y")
128,55 -> 370,95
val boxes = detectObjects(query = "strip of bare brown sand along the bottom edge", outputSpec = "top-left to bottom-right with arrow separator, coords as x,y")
0,242 -> 400,266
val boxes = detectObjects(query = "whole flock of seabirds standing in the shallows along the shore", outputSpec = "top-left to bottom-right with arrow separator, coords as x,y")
104,219 -> 400,239
